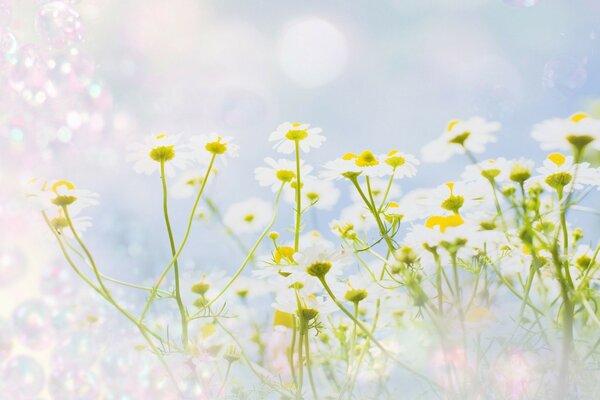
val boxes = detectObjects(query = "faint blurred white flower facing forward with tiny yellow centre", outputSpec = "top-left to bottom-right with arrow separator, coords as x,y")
223,197 -> 273,233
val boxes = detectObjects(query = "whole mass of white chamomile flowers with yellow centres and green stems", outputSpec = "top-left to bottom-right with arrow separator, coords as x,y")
39,113 -> 600,399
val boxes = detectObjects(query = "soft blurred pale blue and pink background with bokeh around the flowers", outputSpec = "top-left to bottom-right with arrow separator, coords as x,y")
0,0 -> 600,399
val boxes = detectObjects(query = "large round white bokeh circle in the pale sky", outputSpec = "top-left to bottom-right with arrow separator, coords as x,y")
279,18 -> 348,87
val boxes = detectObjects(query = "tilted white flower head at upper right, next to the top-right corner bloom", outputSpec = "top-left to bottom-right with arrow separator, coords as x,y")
422,117 -> 500,163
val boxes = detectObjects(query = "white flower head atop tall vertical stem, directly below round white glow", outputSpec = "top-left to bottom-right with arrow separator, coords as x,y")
269,122 -> 326,154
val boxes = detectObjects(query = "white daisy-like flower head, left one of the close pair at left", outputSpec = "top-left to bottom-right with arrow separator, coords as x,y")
127,133 -> 192,176
